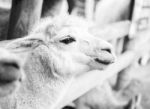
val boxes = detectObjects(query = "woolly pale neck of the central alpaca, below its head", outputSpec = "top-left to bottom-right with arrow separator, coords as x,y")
0,46 -> 72,109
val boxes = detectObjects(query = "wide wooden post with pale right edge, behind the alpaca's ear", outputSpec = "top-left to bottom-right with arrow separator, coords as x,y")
7,0 -> 43,39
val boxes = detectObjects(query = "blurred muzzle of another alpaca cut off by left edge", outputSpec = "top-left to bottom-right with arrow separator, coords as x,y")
0,49 -> 24,97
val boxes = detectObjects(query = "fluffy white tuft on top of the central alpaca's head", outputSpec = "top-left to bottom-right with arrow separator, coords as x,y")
30,15 -> 93,38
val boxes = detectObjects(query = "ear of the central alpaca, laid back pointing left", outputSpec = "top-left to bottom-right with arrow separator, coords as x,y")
5,36 -> 44,65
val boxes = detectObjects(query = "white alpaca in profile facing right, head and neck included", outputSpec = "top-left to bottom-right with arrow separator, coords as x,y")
0,16 -> 115,109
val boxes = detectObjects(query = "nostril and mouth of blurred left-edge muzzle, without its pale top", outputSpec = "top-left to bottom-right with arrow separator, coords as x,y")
0,61 -> 22,97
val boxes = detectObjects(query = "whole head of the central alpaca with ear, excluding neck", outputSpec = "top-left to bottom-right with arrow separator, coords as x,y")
6,17 -> 114,74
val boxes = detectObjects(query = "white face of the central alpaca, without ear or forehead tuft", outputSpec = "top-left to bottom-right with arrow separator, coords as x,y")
44,22 -> 114,74
